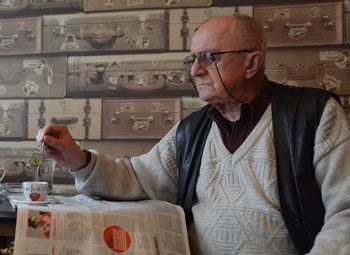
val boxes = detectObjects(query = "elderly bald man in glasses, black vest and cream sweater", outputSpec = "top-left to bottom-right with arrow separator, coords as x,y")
37,16 -> 350,255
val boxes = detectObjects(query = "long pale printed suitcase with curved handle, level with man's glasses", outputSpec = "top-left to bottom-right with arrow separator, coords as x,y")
67,52 -> 197,97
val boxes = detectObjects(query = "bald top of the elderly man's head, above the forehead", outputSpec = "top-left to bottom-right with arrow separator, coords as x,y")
195,14 -> 266,54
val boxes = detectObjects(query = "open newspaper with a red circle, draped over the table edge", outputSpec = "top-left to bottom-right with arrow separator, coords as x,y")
14,195 -> 190,255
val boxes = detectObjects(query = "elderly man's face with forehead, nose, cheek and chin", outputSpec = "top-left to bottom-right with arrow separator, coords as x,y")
191,24 -> 245,105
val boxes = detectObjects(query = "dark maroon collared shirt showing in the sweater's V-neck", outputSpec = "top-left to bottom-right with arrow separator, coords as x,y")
208,81 -> 271,153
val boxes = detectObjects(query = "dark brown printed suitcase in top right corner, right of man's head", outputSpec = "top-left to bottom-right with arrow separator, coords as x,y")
254,1 -> 343,47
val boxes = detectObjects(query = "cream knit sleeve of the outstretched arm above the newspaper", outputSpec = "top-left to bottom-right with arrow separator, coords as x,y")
72,125 -> 177,203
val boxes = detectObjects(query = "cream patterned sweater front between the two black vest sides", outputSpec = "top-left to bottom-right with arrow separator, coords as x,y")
190,104 -> 296,255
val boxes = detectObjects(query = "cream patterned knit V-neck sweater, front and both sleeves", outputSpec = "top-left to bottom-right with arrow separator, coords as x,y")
73,96 -> 350,255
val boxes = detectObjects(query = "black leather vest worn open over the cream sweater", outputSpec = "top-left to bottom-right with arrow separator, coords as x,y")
176,82 -> 339,254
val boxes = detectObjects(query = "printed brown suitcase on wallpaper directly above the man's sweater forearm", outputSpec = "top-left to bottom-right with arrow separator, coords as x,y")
102,98 -> 181,139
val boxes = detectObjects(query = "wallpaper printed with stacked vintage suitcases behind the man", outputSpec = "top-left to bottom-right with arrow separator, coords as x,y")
0,0 -> 350,183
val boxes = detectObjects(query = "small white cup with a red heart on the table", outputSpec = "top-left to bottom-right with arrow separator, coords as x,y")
23,181 -> 49,202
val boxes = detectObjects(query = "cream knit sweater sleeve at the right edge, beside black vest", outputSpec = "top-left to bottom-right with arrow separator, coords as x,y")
309,98 -> 350,255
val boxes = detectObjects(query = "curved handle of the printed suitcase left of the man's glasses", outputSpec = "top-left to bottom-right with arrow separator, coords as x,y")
121,73 -> 165,92
